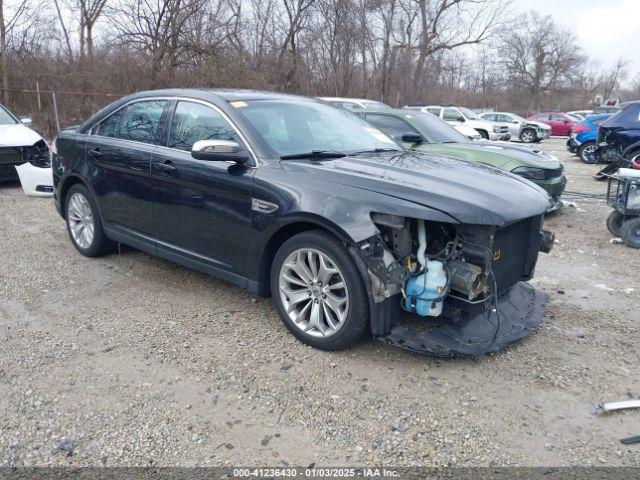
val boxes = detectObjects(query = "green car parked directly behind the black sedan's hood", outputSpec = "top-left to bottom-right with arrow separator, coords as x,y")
354,109 -> 567,211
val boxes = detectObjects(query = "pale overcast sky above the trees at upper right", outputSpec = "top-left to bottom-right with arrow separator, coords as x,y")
512,0 -> 640,77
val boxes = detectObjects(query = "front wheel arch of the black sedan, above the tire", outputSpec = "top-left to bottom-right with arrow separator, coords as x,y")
258,218 -> 353,297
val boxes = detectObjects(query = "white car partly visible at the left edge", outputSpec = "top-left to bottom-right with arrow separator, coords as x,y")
0,105 -> 53,196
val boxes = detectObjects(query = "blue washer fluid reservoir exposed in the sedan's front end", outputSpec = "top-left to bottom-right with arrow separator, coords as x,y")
405,260 -> 447,317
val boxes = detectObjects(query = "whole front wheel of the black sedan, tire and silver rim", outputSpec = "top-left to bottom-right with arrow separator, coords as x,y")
270,230 -> 369,350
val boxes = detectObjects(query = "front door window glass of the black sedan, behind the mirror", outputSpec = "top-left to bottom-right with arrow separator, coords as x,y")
167,101 -> 239,151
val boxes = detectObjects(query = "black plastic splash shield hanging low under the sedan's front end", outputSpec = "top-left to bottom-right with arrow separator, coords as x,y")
378,282 -> 549,357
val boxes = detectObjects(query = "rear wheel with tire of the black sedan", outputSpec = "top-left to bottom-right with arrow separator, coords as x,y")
65,183 -> 112,257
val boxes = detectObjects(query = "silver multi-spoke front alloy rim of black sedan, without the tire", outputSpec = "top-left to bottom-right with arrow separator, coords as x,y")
279,248 -> 349,337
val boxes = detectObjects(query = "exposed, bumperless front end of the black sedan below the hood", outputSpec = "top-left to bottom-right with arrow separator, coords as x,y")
354,213 -> 554,357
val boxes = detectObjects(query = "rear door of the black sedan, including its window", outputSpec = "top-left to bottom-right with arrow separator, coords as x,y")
86,99 -> 167,239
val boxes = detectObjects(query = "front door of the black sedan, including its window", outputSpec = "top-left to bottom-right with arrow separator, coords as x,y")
151,100 -> 254,275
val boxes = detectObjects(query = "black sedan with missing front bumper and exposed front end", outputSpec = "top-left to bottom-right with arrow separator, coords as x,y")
53,90 -> 552,356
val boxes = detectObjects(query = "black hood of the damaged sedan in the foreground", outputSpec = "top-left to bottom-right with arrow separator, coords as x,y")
283,151 -> 549,225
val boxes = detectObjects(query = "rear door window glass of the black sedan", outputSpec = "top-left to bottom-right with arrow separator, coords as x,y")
93,100 -> 167,144
